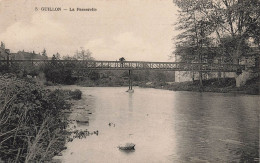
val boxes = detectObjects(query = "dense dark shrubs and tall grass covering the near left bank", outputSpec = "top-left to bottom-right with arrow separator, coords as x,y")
0,74 -> 81,162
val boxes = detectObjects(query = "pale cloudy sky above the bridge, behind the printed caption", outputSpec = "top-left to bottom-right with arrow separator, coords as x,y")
0,0 -> 178,61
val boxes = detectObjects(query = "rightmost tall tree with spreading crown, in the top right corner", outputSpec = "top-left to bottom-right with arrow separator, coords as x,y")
200,0 -> 260,64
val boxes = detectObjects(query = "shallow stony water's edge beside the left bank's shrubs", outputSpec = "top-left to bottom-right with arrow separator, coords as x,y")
49,85 -> 100,163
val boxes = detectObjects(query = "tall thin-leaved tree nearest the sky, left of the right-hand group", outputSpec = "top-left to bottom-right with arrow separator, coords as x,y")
174,0 -> 215,86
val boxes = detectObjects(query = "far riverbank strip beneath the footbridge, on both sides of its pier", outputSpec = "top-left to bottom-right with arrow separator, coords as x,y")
76,77 -> 260,95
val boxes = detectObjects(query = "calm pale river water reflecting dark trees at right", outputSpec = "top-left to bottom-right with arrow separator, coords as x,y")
58,86 -> 260,163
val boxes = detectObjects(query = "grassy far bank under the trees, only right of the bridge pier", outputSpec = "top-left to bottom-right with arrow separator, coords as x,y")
139,77 -> 260,95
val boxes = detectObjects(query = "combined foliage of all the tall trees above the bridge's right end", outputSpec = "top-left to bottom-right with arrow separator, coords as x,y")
174,0 -> 260,63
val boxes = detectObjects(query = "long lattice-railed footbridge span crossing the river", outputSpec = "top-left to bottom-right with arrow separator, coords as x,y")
0,60 -> 244,72
